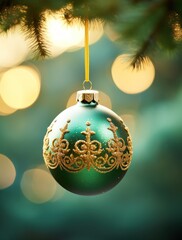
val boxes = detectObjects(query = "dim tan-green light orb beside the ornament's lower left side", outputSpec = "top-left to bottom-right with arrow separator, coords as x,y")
20,168 -> 57,204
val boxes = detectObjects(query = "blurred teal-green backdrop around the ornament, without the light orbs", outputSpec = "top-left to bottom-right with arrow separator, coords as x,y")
0,34 -> 182,240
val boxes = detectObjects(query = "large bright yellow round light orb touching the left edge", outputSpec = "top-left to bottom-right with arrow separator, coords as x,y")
0,66 -> 41,109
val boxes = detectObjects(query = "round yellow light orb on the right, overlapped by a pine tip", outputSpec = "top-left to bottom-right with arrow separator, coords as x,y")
111,54 -> 155,94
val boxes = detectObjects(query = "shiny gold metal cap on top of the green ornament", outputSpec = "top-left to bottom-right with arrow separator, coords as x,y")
76,90 -> 99,103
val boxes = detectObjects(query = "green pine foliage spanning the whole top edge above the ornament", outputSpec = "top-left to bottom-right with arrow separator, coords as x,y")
0,0 -> 182,67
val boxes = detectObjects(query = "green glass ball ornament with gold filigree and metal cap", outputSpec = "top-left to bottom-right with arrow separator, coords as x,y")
43,90 -> 132,195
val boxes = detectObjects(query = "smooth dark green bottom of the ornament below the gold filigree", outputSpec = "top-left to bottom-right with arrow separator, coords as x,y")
50,167 -> 126,196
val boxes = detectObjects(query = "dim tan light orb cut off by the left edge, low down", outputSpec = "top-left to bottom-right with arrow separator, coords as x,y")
0,154 -> 16,189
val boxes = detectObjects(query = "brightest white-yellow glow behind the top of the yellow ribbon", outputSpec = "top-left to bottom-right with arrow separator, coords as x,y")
45,13 -> 103,57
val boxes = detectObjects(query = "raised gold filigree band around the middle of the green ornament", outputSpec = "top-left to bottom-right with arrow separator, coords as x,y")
43,118 -> 132,173
